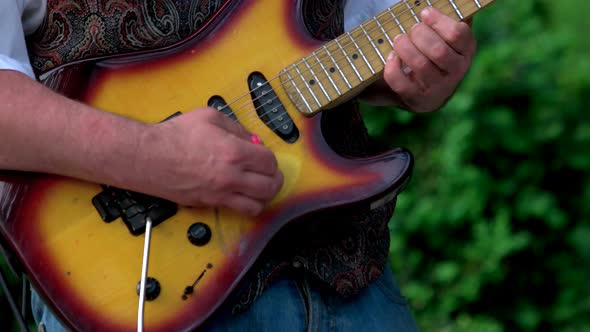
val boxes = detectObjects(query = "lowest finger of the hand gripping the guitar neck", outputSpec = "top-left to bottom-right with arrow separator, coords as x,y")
383,52 -> 420,108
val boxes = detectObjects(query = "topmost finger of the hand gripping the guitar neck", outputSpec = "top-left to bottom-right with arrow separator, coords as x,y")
421,7 -> 475,55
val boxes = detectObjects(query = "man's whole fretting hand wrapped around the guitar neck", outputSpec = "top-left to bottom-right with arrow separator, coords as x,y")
370,7 -> 476,112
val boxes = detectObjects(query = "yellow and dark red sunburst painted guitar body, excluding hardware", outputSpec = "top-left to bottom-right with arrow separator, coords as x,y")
0,0 -> 411,331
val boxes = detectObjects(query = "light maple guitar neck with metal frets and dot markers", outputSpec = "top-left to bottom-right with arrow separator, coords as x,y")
280,0 -> 494,116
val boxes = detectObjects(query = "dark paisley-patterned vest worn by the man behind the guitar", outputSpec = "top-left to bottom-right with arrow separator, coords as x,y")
28,0 -> 395,310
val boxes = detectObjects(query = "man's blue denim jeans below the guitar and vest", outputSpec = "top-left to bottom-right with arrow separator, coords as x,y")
32,267 -> 418,332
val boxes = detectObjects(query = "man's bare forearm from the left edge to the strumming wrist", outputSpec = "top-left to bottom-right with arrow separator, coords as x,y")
0,70 -> 147,187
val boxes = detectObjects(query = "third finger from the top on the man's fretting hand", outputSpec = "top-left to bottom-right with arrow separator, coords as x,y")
393,34 -> 443,90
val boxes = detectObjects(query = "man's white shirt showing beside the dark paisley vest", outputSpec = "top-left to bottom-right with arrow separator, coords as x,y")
0,0 -> 399,77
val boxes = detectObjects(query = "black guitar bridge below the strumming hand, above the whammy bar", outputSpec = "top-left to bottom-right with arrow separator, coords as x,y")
92,186 -> 178,235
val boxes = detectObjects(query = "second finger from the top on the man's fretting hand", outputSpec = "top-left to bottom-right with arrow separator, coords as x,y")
410,23 -> 463,73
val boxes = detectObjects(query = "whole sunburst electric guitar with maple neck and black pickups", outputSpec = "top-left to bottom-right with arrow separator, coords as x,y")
0,0 -> 493,331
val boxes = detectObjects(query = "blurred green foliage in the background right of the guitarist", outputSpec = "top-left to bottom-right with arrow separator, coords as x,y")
364,0 -> 590,332
